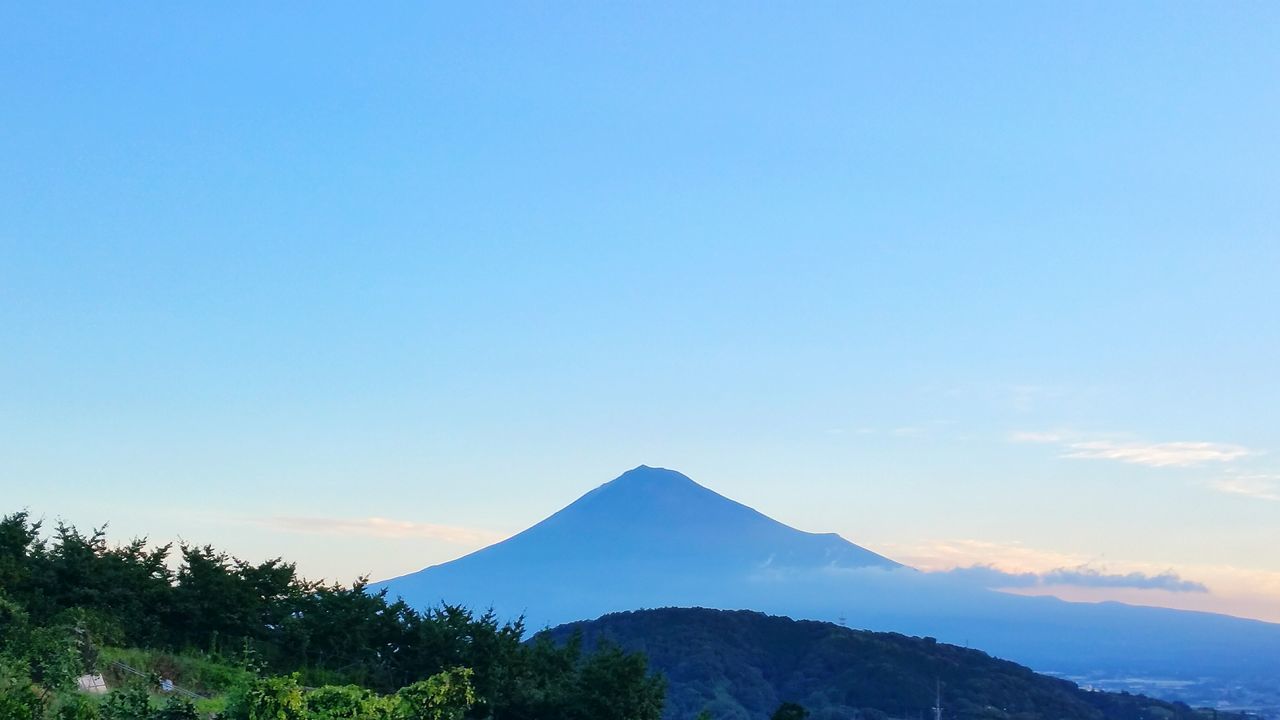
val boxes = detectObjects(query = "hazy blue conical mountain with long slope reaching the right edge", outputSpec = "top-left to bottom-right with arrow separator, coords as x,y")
375,466 -> 1280,702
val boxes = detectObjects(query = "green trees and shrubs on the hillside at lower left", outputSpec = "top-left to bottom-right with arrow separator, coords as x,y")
0,512 -> 663,720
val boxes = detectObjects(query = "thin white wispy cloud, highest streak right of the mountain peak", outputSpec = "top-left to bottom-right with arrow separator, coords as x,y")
1009,430 -> 1258,468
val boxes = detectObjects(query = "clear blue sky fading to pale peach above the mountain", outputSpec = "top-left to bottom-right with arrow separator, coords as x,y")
0,1 -> 1280,621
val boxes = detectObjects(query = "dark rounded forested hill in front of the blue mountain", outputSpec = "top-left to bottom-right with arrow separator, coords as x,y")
548,609 -> 1225,720
